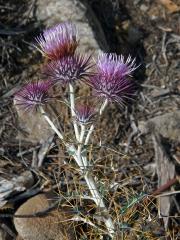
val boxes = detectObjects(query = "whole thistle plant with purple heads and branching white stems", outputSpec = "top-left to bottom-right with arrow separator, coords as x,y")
14,22 -> 137,238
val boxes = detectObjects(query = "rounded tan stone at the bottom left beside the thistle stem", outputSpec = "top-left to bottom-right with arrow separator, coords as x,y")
14,194 -> 76,240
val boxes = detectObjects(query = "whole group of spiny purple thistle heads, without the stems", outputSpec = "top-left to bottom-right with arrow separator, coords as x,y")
14,22 -> 137,116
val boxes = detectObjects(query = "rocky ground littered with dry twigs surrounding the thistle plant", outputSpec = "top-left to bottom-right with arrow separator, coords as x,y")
0,0 -> 180,239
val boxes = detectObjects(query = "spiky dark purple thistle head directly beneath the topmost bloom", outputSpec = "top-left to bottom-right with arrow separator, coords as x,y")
43,54 -> 93,84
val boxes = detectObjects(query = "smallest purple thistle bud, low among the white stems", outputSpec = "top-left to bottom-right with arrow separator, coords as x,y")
75,105 -> 95,124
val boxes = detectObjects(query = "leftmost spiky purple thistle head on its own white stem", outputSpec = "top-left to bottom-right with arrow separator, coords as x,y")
14,81 -> 52,111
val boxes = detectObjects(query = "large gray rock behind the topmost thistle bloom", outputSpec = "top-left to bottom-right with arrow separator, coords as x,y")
37,0 -> 109,55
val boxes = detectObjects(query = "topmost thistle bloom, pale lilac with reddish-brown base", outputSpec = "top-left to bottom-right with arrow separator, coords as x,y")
36,22 -> 78,60
